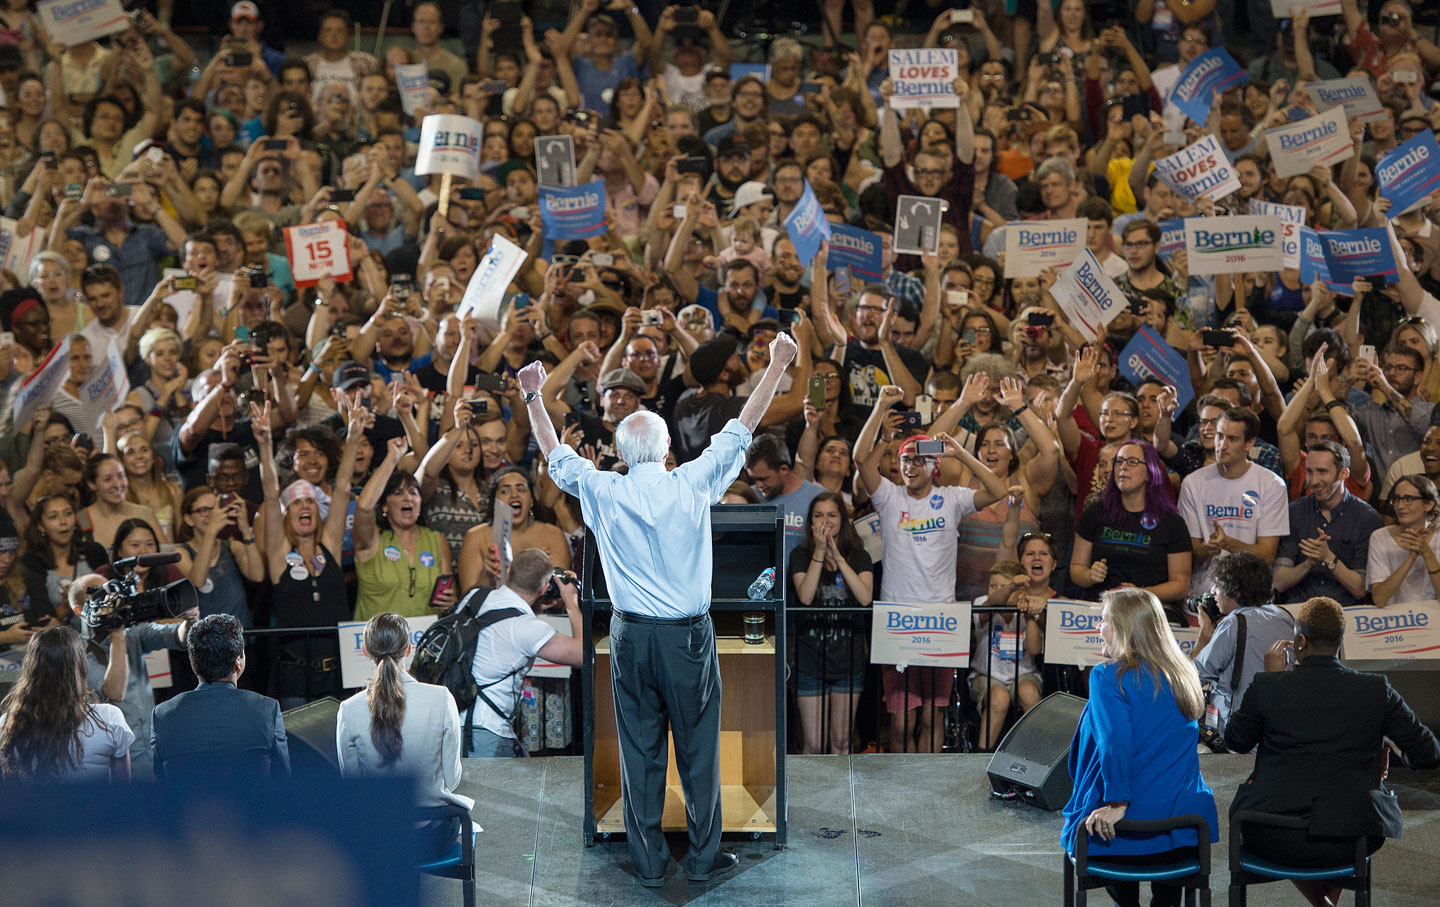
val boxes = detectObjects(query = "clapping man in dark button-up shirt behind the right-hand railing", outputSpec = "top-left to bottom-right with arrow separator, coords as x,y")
1274,441 -> 1384,605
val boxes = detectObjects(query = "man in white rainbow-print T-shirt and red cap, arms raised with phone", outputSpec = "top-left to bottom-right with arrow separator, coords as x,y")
855,384 -> 1007,753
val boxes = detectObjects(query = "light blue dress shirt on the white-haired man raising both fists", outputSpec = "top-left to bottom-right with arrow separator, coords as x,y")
549,419 -> 750,619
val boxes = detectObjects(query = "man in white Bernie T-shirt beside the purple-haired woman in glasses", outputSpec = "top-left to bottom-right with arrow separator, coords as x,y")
1179,409 -> 1290,604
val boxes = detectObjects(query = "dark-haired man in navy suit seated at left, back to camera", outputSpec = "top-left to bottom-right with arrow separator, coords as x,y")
150,615 -> 289,779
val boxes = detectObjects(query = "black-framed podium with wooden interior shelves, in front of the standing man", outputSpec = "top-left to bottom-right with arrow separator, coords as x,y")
580,504 -> 786,847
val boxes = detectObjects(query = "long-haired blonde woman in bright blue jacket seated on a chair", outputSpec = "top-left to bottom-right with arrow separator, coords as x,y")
1060,589 -> 1220,907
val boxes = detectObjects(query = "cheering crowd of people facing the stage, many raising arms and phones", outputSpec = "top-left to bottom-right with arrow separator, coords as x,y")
0,0 -> 1440,766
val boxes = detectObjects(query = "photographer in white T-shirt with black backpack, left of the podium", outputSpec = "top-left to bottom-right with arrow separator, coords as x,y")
469,549 -> 583,759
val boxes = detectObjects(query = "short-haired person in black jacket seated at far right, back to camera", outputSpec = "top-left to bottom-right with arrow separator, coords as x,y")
1225,597 -> 1440,906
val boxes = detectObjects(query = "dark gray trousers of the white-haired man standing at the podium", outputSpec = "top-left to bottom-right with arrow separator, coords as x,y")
611,610 -> 724,878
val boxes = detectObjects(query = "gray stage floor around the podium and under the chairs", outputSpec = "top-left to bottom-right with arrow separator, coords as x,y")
423,756 -> 1440,907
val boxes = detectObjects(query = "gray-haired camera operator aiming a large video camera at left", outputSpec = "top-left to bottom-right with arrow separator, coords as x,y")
69,573 -> 200,780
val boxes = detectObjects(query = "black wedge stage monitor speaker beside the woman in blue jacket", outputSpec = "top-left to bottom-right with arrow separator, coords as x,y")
986,692 -> 1086,809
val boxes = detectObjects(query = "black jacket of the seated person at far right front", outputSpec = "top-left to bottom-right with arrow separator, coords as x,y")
1225,655 -> 1440,838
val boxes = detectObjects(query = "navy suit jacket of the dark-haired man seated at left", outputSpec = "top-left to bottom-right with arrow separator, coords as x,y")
150,681 -> 289,779
